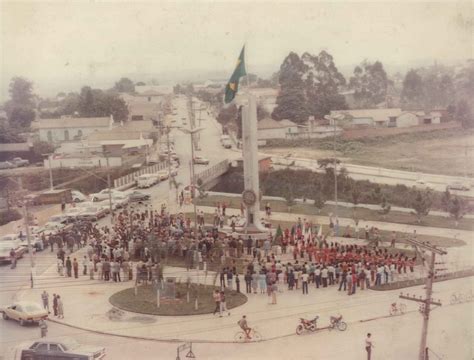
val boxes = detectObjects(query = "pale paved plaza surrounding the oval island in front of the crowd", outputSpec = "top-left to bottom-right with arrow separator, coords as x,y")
19,253 -> 472,342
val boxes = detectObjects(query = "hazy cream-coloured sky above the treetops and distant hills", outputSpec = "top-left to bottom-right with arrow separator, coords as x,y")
0,0 -> 473,101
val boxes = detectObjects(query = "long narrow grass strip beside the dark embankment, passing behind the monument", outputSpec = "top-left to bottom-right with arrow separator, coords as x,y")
197,195 -> 474,231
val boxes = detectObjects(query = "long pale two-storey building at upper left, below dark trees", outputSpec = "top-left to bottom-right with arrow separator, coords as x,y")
38,116 -> 114,143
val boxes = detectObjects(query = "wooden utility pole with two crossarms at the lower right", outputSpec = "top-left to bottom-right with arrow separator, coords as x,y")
400,239 -> 446,360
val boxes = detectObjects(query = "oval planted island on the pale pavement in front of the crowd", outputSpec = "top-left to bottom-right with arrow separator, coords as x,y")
109,283 -> 247,316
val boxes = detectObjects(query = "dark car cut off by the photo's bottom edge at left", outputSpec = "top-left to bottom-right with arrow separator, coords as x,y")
16,337 -> 105,360
